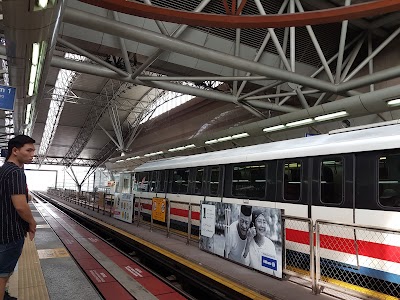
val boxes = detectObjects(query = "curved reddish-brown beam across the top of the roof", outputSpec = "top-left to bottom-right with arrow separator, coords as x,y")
81,0 -> 400,28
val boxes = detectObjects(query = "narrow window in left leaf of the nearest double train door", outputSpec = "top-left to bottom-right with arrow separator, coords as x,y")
283,161 -> 302,201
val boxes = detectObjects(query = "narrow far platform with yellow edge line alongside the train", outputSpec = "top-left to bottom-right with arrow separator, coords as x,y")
36,194 -> 348,300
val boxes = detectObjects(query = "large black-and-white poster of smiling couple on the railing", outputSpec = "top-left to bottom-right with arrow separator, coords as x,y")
200,202 -> 284,278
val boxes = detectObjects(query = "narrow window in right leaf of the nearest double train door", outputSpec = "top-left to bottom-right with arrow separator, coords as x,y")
320,157 -> 343,204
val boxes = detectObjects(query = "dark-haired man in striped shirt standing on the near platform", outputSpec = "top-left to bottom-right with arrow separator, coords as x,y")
0,135 -> 36,300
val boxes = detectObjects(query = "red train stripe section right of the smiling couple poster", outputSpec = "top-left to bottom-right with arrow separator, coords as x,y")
286,228 -> 400,263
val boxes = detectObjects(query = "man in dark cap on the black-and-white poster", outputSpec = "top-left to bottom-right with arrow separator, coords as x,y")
224,205 -> 252,264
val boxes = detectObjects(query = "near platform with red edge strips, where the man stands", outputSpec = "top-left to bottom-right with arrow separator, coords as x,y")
8,199 -> 187,300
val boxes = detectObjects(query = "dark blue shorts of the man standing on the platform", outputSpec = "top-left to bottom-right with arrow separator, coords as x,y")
0,239 -> 25,278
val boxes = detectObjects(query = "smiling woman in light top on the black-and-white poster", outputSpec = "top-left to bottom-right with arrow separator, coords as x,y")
243,209 -> 280,277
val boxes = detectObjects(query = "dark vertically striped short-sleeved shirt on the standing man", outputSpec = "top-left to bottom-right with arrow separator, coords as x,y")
0,161 -> 29,244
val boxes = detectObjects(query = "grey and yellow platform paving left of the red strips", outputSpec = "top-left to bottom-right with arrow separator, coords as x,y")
8,202 -> 102,300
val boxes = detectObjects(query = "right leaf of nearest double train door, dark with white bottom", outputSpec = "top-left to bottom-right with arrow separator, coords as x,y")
310,154 -> 355,223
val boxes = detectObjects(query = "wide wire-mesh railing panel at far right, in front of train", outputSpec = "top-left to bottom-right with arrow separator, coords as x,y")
315,220 -> 400,299
